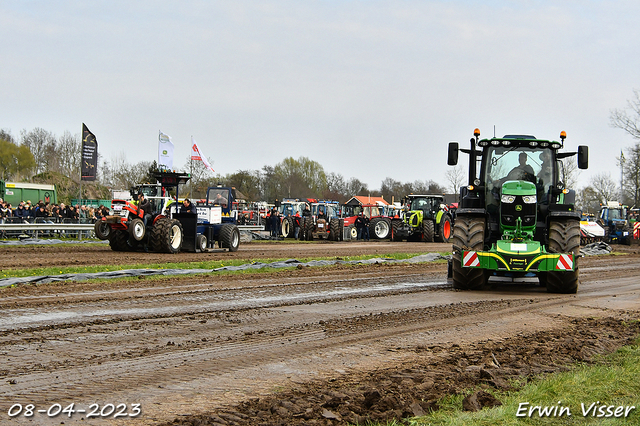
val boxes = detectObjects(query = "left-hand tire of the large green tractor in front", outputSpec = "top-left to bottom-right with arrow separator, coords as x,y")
452,216 -> 488,290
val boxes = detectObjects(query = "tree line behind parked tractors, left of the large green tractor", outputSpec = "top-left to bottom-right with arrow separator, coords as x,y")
0,128 -> 446,202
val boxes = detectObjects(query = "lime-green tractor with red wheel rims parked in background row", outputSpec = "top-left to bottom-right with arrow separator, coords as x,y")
391,194 -> 453,243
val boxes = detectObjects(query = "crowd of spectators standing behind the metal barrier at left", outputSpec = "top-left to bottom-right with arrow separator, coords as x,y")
0,198 -> 109,223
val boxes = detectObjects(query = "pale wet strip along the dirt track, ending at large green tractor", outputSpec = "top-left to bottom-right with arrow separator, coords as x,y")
0,282 -> 447,329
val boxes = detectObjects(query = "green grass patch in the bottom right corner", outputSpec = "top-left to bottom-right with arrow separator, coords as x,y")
409,342 -> 640,426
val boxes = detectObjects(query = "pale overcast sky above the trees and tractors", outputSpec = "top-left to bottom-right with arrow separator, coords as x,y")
0,0 -> 640,189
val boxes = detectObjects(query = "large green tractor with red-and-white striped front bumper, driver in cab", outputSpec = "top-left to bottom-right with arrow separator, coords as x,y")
448,129 -> 589,293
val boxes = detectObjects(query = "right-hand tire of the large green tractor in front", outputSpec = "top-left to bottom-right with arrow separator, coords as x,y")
538,219 -> 580,294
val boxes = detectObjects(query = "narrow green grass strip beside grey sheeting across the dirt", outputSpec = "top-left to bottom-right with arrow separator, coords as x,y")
0,253 -> 444,279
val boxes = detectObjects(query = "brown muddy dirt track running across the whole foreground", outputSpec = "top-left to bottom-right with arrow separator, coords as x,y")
0,241 -> 640,425
